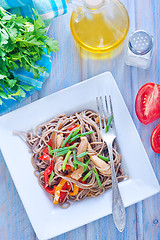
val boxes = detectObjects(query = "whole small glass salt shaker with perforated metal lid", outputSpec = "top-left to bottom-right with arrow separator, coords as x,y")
125,30 -> 153,69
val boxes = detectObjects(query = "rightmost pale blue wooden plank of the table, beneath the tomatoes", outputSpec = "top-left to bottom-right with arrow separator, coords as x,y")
135,0 -> 160,240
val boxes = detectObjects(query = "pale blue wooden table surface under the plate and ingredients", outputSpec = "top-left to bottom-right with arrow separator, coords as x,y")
0,0 -> 160,240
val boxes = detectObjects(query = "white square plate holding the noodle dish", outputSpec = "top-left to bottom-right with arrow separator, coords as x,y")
0,72 -> 160,240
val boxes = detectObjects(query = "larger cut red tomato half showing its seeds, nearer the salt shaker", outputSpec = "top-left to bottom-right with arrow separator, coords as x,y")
135,83 -> 160,124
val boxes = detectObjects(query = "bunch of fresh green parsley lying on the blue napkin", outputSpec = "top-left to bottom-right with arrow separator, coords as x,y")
0,7 -> 59,105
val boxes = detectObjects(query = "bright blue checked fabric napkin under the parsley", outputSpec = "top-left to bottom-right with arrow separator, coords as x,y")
0,0 -> 67,115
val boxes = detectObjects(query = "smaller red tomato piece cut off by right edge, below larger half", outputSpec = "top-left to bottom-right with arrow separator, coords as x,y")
150,124 -> 160,154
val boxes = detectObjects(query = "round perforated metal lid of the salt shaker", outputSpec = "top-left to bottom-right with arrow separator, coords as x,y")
129,30 -> 153,55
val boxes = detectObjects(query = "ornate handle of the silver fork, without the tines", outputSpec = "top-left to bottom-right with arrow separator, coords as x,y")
108,144 -> 126,232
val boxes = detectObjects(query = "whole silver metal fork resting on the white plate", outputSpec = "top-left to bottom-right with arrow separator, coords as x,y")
96,96 -> 126,232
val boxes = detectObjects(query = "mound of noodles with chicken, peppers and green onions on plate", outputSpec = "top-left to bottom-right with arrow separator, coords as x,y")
23,110 -> 125,207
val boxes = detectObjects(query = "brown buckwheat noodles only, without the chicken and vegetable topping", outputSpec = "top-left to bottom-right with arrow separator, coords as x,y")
15,110 -> 126,208
